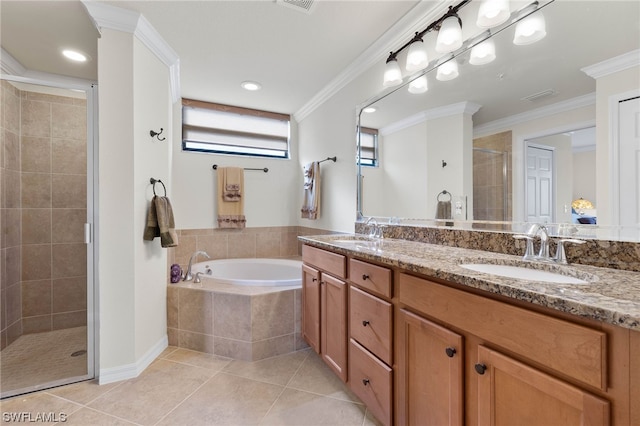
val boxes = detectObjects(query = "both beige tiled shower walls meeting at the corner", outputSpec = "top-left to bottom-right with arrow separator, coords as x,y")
0,81 -> 87,348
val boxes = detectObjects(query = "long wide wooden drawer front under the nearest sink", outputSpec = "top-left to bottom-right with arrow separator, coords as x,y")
398,273 -> 607,390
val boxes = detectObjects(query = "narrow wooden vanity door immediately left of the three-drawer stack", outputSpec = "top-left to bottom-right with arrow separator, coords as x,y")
320,274 -> 347,382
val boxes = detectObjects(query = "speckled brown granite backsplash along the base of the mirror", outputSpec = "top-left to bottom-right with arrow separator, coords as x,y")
356,221 -> 640,272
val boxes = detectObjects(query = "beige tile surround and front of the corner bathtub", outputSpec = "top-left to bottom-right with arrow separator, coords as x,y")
167,226 -> 329,360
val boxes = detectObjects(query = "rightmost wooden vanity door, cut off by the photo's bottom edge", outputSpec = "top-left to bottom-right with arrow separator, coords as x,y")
475,346 -> 610,426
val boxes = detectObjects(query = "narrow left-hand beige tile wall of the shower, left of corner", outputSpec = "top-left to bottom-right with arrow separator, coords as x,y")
0,81 -> 22,349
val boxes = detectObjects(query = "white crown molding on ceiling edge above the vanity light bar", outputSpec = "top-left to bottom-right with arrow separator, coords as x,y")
293,1 -> 453,123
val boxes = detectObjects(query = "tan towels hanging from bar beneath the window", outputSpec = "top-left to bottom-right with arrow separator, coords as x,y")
217,167 -> 247,229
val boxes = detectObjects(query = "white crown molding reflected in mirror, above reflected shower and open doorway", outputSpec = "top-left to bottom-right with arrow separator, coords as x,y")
473,92 -> 596,138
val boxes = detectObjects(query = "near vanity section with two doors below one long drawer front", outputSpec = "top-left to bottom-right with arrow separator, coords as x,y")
396,273 -> 611,426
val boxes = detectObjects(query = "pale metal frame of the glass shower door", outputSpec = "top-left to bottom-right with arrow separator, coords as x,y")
0,74 -> 99,398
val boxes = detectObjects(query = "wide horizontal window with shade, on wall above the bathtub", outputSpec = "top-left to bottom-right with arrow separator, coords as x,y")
182,99 -> 290,158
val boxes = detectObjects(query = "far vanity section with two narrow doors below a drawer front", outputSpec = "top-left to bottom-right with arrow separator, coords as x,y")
302,245 -> 348,382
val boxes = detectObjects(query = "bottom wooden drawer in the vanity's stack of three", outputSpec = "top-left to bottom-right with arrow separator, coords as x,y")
349,339 -> 393,425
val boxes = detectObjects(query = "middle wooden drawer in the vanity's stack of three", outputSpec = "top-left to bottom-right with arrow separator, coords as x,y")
349,287 -> 393,365
